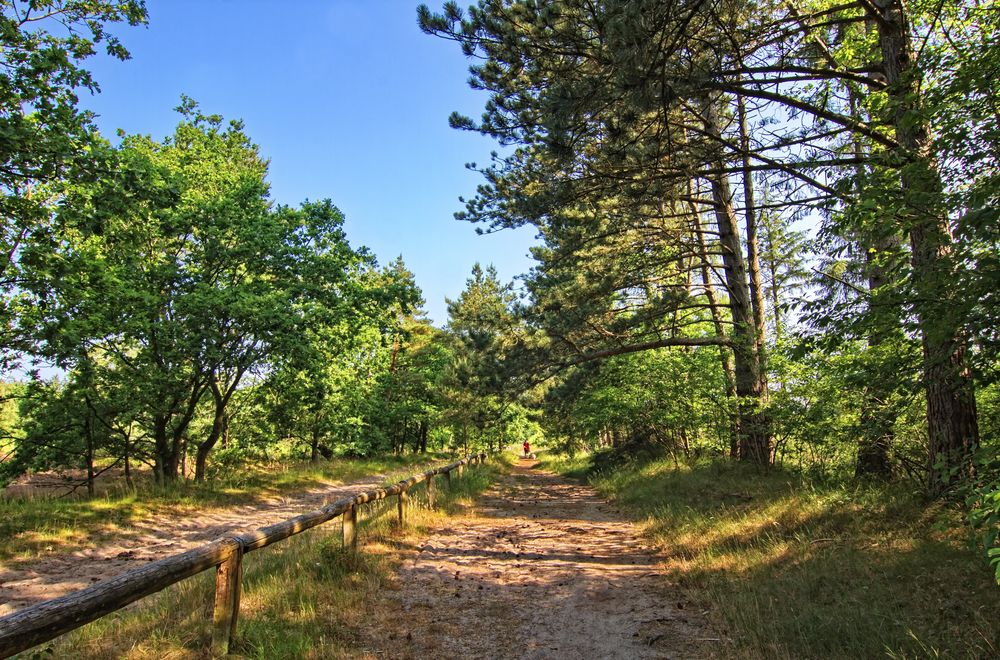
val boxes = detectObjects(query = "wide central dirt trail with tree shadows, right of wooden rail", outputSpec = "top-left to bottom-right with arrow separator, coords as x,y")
365,460 -> 721,658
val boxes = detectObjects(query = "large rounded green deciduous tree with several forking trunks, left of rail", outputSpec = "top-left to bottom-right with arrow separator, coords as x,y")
7,99 -> 415,480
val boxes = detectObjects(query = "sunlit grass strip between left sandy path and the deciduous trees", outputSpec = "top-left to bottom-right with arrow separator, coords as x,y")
0,454 -> 446,562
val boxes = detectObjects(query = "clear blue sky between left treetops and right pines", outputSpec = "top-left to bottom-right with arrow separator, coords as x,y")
81,0 -> 533,325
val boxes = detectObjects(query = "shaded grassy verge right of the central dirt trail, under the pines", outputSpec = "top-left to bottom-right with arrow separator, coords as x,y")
546,457 -> 1000,659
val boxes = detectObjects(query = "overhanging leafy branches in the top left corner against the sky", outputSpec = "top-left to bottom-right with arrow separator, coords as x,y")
0,0 -> 146,371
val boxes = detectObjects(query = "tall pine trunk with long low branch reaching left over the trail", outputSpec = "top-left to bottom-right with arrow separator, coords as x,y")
702,99 -> 771,465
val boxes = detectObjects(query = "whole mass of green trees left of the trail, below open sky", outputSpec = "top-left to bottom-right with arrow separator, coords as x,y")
0,0 -> 537,492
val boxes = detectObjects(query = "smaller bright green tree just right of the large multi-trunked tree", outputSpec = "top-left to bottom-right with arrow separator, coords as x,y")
262,255 -> 424,461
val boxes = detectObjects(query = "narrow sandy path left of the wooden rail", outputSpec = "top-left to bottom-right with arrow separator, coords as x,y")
0,465 -> 430,616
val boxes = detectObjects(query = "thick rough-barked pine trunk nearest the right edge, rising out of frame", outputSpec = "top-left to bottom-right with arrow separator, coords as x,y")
876,0 -> 979,494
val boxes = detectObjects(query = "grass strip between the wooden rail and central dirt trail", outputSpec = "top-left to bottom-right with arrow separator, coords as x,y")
13,456 -> 504,660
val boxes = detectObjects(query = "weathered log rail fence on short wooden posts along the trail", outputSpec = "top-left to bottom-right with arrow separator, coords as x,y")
0,454 -> 486,658
